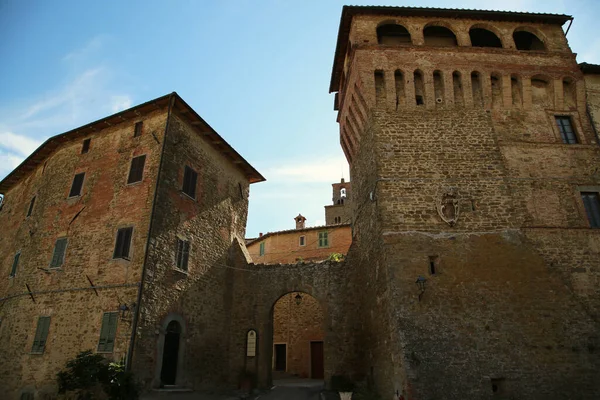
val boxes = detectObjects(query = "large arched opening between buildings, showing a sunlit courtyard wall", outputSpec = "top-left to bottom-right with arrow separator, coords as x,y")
272,292 -> 325,380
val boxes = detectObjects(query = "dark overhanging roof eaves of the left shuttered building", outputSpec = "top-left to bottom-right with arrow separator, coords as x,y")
0,92 -> 265,193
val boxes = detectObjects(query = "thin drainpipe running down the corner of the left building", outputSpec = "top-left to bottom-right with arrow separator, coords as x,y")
125,92 -> 177,371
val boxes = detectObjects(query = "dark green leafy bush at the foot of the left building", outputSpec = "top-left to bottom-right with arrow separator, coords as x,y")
56,350 -> 139,400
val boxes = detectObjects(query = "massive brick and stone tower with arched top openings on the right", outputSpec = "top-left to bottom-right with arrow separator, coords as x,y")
330,6 -> 600,399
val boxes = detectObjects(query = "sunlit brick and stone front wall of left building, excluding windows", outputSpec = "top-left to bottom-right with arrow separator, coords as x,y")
0,109 -> 166,399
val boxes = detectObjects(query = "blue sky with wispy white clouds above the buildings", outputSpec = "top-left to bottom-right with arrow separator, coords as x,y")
0,0 -> 600,237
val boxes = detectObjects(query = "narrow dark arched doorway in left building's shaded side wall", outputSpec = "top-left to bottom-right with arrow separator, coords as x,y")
153,314 -> 186,387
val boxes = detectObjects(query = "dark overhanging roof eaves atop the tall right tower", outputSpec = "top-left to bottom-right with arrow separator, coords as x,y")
329,6 -> 573,93
